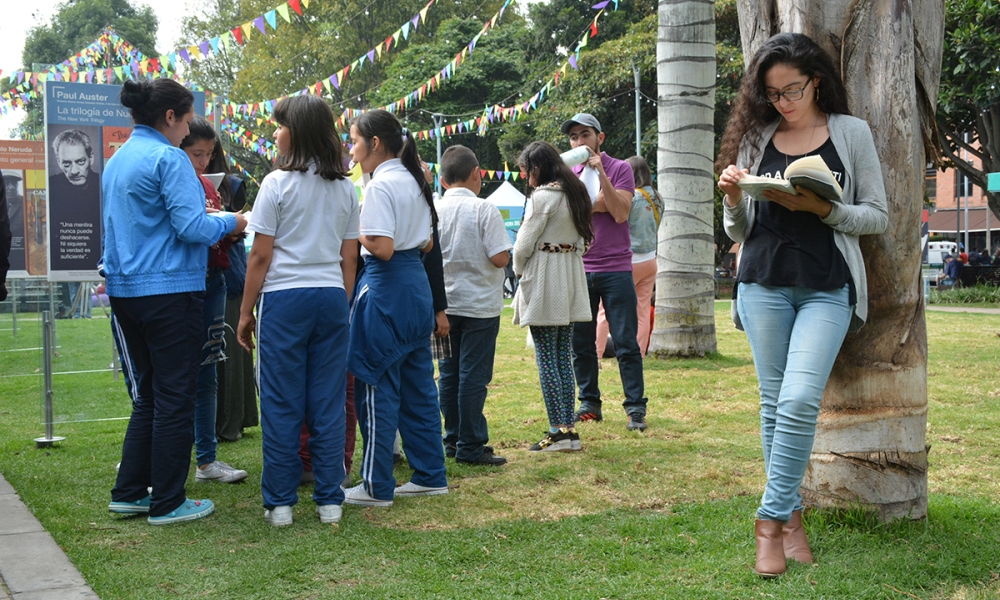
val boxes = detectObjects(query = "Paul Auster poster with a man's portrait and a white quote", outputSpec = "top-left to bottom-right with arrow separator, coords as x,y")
45,82 -> 205,281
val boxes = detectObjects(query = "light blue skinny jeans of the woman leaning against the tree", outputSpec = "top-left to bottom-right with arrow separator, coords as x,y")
736,283 -> 853,522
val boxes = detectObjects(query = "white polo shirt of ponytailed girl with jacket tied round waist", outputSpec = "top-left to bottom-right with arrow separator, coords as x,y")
361,158 -> 433,256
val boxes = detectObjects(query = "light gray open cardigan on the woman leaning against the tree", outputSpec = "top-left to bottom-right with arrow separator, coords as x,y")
722,114 -> 889,331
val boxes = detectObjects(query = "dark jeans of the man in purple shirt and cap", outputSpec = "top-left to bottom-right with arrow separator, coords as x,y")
573,271 -> 646,414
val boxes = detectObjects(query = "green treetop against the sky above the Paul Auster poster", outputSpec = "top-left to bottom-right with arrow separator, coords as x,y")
20,0 -> 158,135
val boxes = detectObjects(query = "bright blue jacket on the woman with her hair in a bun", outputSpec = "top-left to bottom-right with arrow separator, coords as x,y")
102,125 -> 236,298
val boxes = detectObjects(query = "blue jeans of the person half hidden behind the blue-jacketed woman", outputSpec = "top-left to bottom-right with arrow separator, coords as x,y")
194,269 -> 226,467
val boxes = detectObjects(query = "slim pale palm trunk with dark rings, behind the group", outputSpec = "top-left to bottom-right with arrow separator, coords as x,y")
649,0 -> 715,356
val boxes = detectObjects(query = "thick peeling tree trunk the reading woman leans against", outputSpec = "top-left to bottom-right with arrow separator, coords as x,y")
738,0 -> 944,519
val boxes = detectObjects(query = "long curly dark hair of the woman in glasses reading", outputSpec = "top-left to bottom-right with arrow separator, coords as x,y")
715,33 -> 850,173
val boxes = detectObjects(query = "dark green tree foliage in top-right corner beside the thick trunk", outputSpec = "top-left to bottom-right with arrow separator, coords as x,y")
936,0 -> 1000,216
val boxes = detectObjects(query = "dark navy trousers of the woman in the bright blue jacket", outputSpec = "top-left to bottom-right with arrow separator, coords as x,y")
111,292 -> 205,517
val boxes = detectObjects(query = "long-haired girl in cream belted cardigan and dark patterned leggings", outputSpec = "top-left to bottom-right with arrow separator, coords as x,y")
513,142 -> 594,452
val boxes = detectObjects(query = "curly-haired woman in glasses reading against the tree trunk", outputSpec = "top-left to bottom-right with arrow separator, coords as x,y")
716,33 -> 888,577
